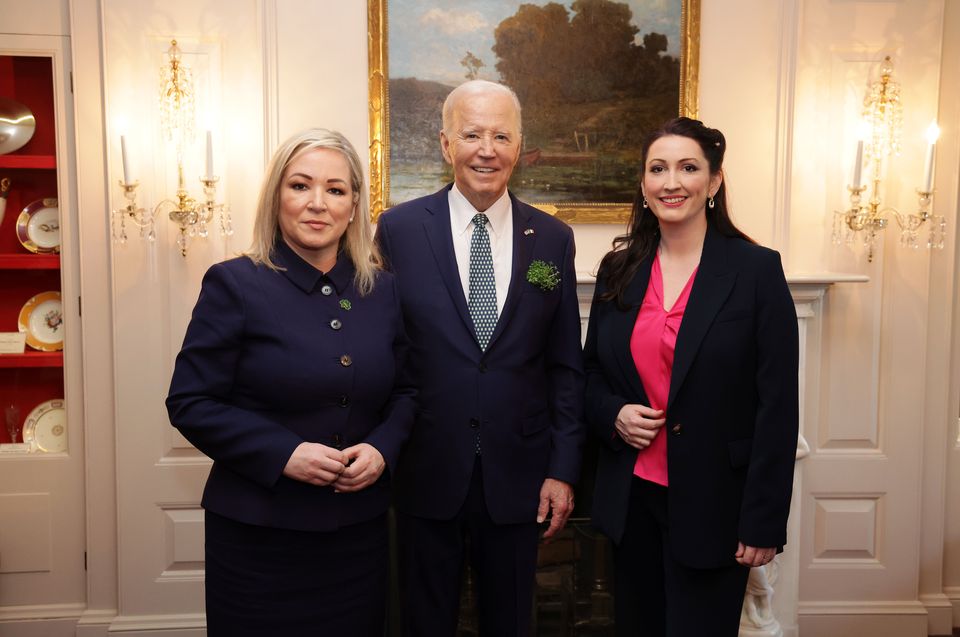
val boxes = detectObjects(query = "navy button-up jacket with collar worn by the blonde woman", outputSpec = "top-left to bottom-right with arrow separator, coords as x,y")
167,239 -> 415,531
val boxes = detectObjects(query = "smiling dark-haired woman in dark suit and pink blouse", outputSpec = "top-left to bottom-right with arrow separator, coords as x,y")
584,118 -> 798,637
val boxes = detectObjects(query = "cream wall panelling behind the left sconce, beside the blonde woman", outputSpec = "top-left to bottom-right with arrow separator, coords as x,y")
102,0 -> 265,631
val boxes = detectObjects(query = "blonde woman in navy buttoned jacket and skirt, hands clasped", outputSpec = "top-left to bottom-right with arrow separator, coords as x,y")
167,129 -> 414,637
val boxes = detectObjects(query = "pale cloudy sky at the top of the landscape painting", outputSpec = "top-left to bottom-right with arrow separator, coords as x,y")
387,0 -> 681,85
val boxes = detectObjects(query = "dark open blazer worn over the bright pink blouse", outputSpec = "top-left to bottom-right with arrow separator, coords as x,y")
584,229 -> 799,568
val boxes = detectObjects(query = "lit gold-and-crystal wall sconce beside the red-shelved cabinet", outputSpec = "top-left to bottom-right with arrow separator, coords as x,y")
113,40 -> 233,257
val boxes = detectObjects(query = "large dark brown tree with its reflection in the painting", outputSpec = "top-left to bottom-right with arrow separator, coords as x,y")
493,0 -> 680,199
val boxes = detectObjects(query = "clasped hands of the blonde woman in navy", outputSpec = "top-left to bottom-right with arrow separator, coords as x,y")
283,442 -> 386,492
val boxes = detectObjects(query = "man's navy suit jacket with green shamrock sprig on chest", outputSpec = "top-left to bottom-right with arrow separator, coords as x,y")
377,186 -> 585,524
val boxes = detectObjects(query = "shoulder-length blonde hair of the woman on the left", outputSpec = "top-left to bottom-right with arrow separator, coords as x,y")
245,128 -> 383,296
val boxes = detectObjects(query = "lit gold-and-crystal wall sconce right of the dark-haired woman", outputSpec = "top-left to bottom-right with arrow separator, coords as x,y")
833,56 -> 946,262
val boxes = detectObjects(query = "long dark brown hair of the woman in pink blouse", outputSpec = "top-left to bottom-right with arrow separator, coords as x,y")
600,117 -> 754,309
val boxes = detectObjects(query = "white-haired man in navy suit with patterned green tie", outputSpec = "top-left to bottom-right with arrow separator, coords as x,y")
377,80 -> 585,637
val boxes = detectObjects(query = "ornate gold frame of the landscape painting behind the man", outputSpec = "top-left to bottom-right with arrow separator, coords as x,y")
367,0 -> 700,224
